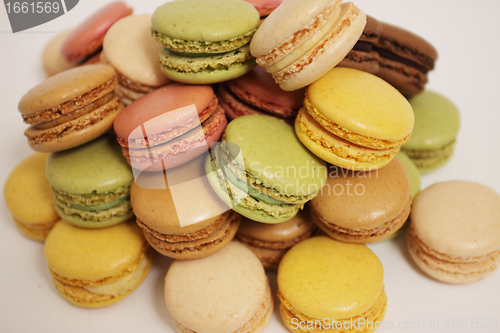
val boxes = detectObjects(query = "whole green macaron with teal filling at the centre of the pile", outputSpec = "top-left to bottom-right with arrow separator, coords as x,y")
206,115 -> 327,223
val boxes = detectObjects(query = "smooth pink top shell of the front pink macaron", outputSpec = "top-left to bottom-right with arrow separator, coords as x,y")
114,83 -> 215,140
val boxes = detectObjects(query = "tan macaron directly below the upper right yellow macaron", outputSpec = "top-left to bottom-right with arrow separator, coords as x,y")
310,157 -> 412,243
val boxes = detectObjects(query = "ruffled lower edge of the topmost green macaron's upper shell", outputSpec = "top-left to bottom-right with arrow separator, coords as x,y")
151,27 -> 257,53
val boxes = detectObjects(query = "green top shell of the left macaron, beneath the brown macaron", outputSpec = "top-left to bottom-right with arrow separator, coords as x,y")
46,135 -> 133,194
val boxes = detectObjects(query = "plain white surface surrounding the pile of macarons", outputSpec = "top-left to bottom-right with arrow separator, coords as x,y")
0,0 -> 500,333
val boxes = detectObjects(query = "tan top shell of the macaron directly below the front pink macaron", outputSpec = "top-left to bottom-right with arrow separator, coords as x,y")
130,156 -> 229,235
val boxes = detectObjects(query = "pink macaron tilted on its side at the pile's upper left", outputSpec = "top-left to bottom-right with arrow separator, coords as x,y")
61,1 -> 132,64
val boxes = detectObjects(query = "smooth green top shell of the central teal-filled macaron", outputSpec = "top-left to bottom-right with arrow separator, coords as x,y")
224,115 -> 327,197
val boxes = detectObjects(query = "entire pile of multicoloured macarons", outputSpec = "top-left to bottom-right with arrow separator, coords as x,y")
4,0 -> 500,333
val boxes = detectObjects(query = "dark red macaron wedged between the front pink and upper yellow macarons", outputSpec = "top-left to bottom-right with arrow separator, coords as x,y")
217,66 -> 305,119
